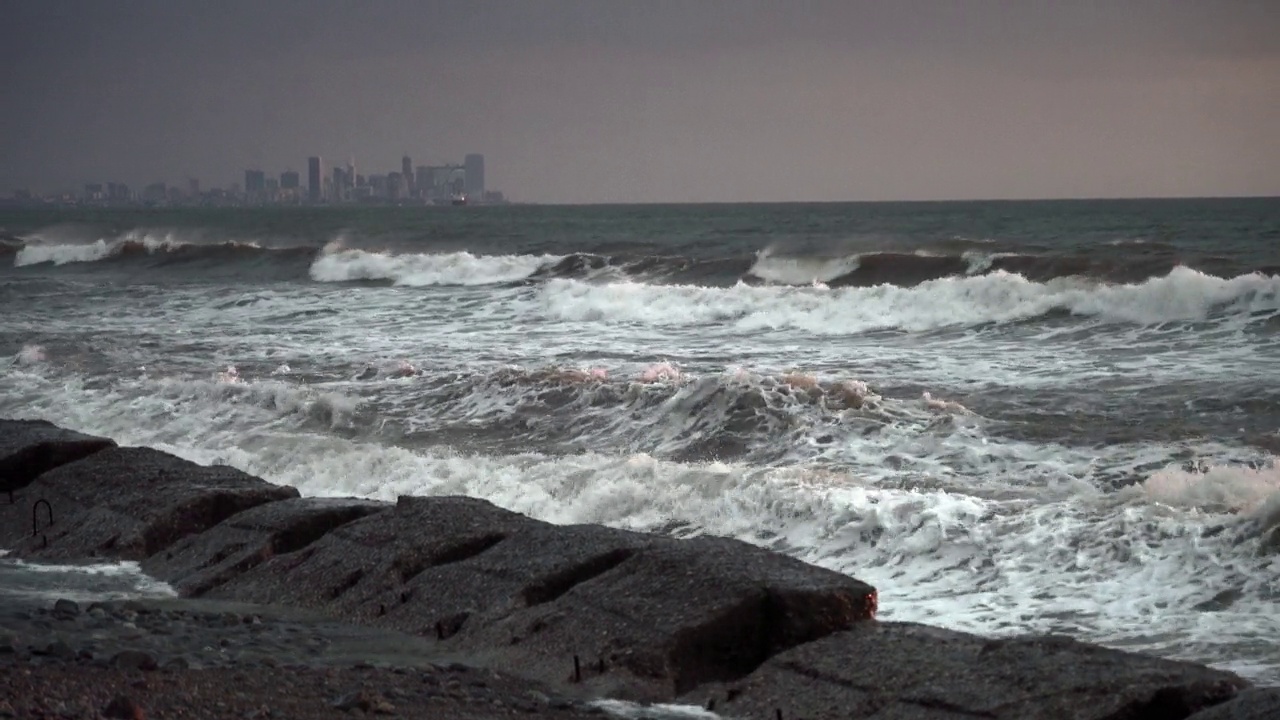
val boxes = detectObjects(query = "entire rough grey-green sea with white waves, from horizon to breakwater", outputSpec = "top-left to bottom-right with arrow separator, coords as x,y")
0,199 -> 1280,682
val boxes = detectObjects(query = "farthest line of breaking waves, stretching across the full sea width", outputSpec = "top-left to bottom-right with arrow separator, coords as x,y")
0,222 -> 1280,288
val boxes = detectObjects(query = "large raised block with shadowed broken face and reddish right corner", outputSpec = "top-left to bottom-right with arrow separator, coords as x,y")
456,528 -> 876,700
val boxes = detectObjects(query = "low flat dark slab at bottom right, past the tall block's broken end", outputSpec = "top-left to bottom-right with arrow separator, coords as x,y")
685,623 -> 1247,720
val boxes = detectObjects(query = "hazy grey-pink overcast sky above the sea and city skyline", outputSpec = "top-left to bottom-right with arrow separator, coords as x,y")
0,0 -> 1280,202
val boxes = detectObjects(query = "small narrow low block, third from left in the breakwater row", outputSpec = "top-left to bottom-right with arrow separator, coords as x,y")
142,497 -> 390,594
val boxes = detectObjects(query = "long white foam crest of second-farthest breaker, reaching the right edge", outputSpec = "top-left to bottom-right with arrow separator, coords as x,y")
540,268 -> 1280,334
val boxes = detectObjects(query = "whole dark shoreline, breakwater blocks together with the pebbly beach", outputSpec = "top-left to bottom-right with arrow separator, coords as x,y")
0,420 -> 1280,720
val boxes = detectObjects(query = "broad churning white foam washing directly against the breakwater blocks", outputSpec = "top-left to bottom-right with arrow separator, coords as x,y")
5,358 -> 1280,678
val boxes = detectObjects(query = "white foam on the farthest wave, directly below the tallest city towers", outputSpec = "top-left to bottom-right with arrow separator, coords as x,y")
311,243 -> 559,287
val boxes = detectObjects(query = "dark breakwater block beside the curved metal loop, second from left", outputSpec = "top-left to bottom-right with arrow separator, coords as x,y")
3,447 -> 298,560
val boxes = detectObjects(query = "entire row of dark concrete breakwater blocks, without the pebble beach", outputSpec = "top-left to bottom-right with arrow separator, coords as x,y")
0,421 -> 1259,707
